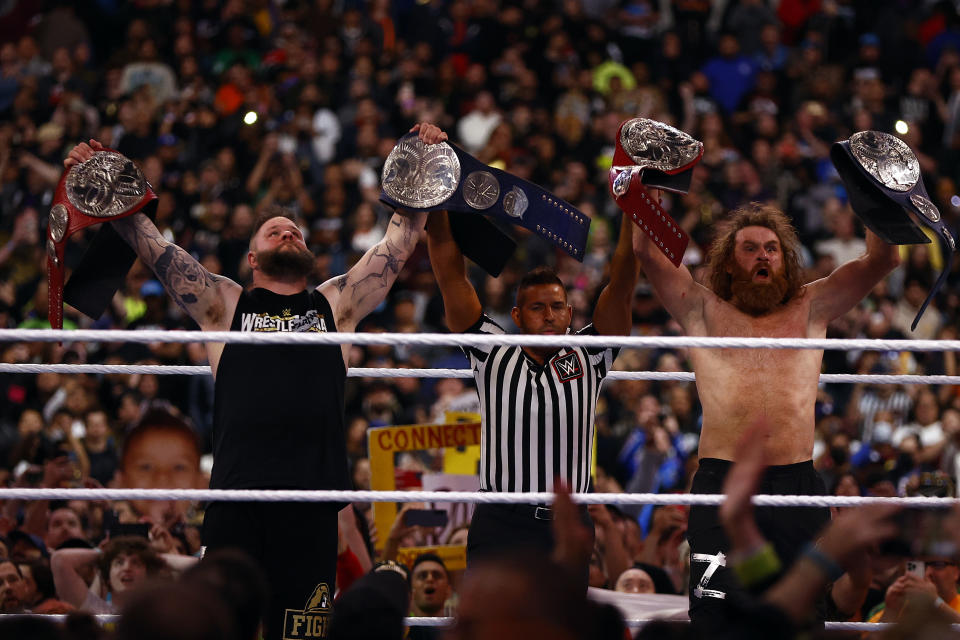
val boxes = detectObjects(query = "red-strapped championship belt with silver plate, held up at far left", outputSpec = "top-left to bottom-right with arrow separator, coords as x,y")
47,149 -> 157,329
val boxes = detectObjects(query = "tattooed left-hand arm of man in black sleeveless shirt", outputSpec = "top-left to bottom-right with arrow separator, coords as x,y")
111,213 -> 240,329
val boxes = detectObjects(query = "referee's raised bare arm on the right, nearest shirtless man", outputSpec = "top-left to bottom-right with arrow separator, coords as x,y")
593,215 -> 640,336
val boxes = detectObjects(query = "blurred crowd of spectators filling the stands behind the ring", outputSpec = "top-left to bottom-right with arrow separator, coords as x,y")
0,0 -> 960,636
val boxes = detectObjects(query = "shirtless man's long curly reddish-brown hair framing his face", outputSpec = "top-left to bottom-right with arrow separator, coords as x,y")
707,202 -> 805,301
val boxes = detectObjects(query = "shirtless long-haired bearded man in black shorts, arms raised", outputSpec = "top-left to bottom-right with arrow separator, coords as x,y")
634,203 -> 899,637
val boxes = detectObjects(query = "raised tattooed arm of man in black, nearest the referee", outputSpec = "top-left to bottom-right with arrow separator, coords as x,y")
320,211 -> 427,331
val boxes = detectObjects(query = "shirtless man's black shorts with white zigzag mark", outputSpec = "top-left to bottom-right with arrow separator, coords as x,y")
687,458 -> 830,634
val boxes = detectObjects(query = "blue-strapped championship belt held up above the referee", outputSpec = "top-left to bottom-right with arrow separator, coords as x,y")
380,133 -> 590,276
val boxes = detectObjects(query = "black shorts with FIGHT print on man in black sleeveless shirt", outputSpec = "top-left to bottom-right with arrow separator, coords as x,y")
203,502 -> 340,640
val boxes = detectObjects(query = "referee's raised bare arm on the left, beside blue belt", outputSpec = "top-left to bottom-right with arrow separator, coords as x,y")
427,211 -> 482,333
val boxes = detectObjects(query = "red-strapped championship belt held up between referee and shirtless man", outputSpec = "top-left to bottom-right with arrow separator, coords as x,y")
610,118 -> 703,267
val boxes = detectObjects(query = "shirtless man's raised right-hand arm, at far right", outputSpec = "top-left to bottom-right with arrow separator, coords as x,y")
808,229 -> 900,325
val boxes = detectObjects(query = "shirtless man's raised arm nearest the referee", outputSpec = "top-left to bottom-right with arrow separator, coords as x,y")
630,201 -> 709,333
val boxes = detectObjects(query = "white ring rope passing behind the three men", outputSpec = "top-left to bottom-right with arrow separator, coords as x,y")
0,363 -> 960,385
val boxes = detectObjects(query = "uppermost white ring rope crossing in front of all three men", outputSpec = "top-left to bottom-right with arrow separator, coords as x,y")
0,329 -> 960,351
